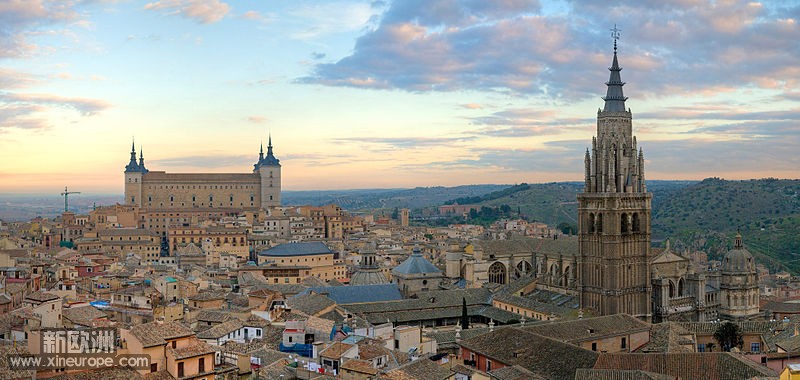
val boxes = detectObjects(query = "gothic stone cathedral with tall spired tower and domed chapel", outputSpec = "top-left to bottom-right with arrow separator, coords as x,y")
446,37 -> 758,322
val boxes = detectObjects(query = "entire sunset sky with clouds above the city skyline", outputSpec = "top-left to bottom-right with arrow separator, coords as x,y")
0,0 -> 800,193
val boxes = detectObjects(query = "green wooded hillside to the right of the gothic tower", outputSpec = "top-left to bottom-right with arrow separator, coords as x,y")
653,178 -> 800,273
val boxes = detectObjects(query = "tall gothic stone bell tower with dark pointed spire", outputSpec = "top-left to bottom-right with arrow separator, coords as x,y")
578,35 -> 652,319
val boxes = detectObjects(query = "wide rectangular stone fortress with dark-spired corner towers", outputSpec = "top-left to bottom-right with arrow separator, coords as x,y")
124,137 -> 281,213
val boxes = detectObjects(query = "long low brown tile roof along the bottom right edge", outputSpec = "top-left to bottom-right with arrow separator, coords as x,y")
594,352 -> 777,380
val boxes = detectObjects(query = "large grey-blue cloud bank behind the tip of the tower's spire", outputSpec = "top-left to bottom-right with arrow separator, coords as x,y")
299,0 -> 800,100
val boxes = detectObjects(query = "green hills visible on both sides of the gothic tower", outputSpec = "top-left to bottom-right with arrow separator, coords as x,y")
438,178 -> 800,274
